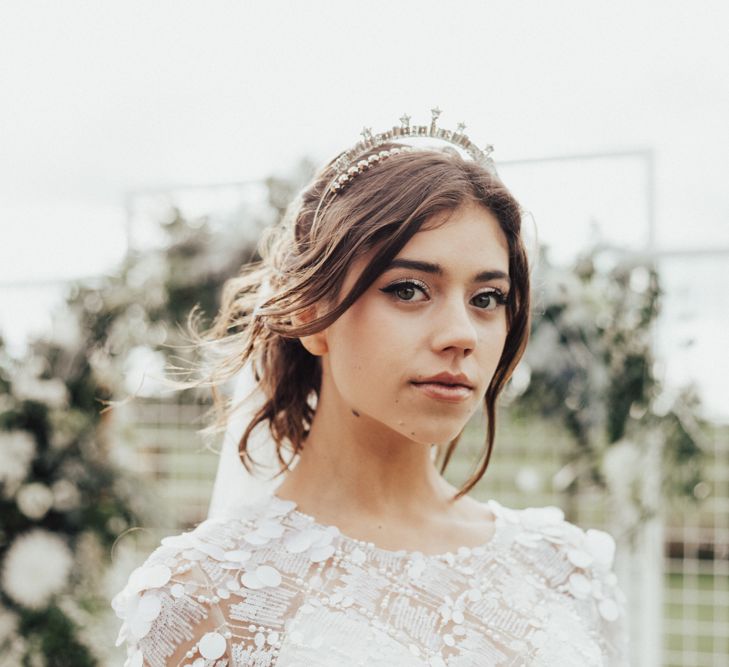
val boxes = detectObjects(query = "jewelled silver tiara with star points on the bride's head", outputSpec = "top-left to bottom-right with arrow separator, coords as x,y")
329,107 -> 496,193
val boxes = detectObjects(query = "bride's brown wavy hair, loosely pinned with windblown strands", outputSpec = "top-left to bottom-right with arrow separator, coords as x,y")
189,143 -> 530,499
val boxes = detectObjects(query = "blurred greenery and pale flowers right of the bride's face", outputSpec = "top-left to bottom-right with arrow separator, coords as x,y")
509,248 -> 705,537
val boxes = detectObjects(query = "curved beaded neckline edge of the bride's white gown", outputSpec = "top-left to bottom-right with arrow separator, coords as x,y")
270,493 -> 504,563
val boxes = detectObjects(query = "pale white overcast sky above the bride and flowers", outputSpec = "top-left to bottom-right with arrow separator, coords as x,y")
0,0 -> 729,414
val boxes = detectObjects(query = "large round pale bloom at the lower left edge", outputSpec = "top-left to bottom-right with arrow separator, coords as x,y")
1,528 -> 73,609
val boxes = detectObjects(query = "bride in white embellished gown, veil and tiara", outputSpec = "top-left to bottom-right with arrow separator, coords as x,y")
112,109 -> 627,667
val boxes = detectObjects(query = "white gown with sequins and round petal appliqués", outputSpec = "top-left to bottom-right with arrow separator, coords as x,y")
112,494 -> 628,667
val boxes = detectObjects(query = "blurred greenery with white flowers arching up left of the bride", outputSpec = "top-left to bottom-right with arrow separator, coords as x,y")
0,170 -> 306,667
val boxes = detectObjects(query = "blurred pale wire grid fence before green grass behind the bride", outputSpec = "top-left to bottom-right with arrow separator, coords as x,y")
112,399 -> 729,667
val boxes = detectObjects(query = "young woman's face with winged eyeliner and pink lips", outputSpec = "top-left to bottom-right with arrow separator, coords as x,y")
321,204 -> 510,444
